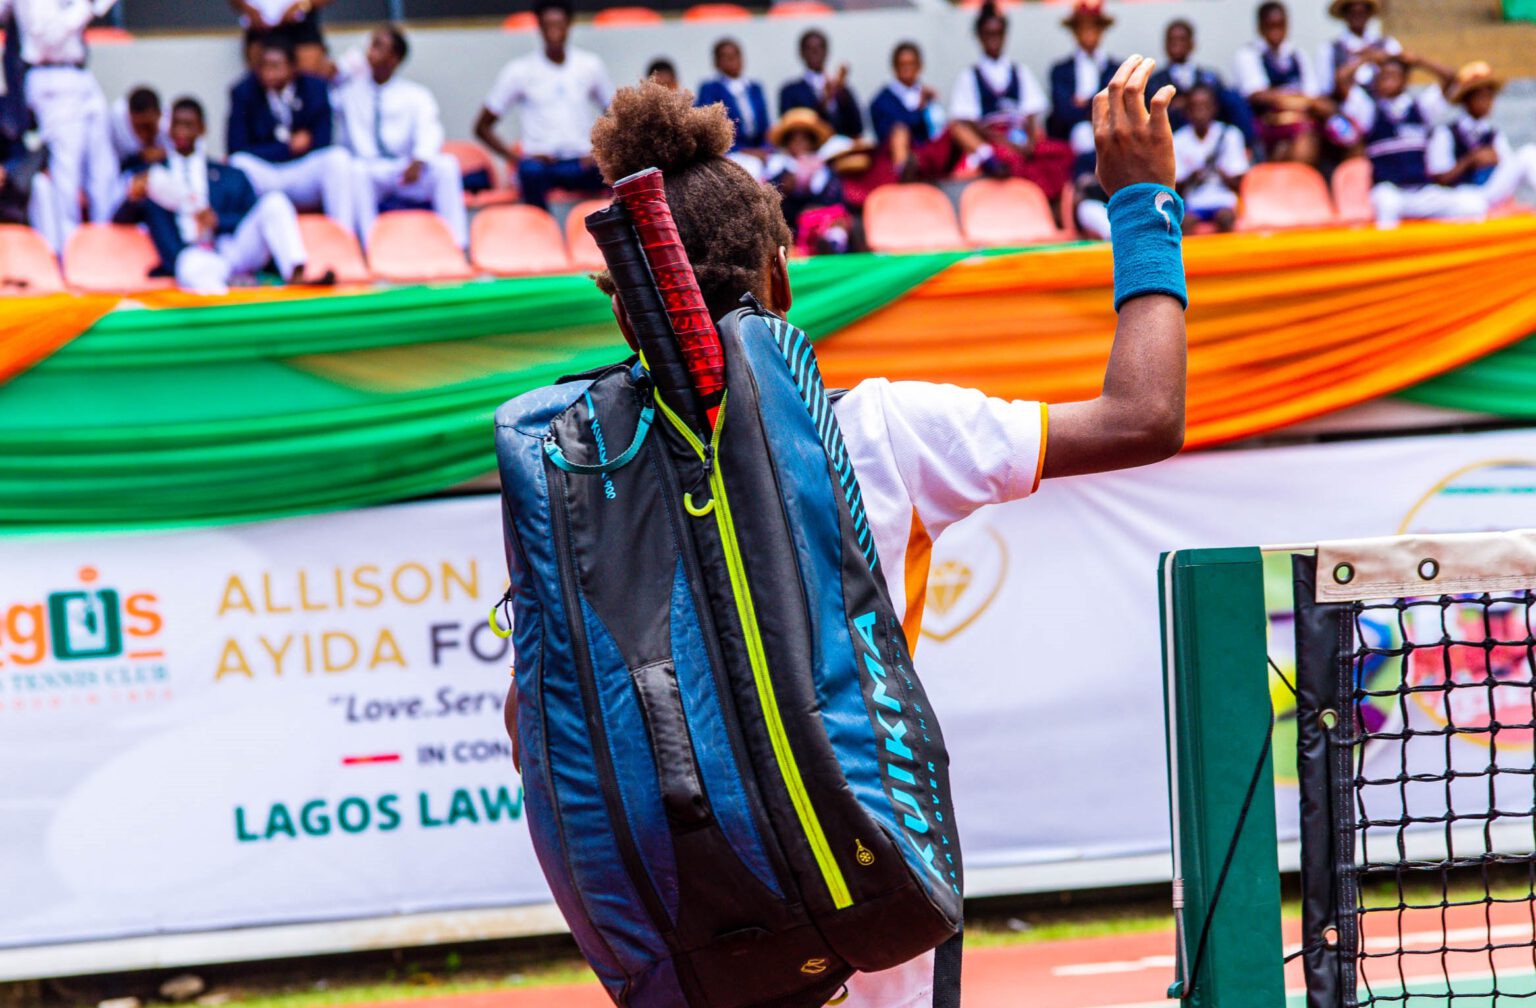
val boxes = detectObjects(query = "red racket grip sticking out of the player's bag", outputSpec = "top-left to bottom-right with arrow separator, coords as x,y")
613,167 -> 725,407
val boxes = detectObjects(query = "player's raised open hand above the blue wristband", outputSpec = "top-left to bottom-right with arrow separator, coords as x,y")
1094,55 -> 1177,195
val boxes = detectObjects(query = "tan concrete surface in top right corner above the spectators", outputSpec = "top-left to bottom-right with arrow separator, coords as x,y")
1384,0 -> 1536,77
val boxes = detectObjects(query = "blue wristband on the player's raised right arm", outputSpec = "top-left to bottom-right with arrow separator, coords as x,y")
1109,183 -> 1189,312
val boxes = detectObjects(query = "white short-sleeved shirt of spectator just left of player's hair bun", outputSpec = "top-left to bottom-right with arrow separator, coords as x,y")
484,48 -> 613,158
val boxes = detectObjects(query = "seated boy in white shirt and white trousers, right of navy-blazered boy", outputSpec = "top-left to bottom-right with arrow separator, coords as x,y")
332,25 -> 470,249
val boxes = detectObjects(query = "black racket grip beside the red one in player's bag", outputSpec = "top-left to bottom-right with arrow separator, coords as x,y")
587,201 -> 710,432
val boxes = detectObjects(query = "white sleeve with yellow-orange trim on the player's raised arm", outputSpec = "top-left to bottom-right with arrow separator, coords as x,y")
859,380 -> 1046,538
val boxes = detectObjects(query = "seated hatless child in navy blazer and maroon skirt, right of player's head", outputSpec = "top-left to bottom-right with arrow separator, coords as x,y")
860,41 -> 955,185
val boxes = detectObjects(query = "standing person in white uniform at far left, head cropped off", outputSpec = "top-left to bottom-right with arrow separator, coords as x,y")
15,0 -> 118,238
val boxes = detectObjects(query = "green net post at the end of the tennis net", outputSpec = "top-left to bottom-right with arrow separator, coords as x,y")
1160,549 -> 1286,1008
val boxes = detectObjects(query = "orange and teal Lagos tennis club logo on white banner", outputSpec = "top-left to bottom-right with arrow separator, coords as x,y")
0,565 -> 170,713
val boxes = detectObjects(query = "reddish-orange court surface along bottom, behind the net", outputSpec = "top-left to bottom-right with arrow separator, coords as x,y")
373,904 -> 1536,1008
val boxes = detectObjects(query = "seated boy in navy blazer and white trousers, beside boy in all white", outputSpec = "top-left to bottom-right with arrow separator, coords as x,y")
226,34 -> 356,229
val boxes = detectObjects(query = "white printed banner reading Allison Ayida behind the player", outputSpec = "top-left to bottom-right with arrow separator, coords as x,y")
0,432 -> 1536,947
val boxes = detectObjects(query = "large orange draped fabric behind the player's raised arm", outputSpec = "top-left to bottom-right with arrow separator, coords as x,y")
817,215 -> 1536,447
